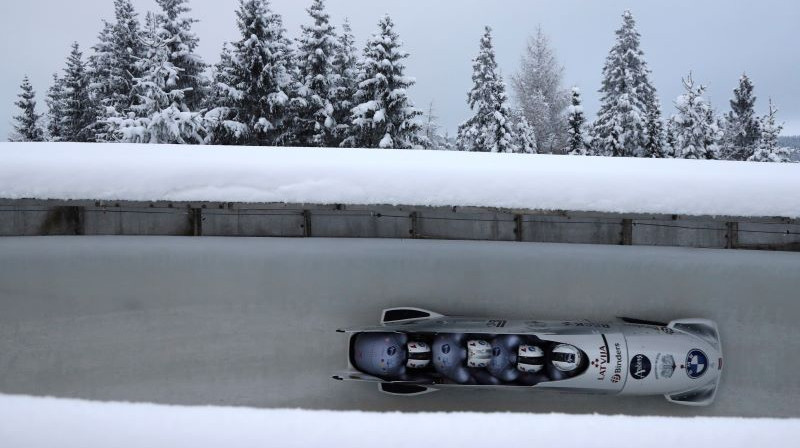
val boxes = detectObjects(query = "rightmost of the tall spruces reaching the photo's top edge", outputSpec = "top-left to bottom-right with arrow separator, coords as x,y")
294,0 -> 337,147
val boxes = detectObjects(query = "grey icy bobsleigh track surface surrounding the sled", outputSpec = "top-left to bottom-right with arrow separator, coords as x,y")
0,237 -> 800,417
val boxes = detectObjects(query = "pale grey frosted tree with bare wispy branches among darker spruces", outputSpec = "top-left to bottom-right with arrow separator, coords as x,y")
512,27 -> 569,153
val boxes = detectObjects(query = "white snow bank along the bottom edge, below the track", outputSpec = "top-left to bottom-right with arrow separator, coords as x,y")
0,396 -> 800,448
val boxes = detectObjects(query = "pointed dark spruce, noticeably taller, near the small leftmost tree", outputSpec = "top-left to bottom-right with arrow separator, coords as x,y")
59,42 -> 96,142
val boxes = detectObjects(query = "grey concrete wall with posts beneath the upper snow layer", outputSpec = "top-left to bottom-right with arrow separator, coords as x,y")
0,200 -> 800,251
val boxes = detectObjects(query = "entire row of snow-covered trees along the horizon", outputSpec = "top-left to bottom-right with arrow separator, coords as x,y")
11,0 -> 790,162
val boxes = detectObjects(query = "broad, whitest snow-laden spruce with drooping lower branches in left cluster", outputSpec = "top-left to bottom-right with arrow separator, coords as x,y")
107,13 -> 205,144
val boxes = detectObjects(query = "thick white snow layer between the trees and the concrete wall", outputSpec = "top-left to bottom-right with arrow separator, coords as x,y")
0,143 -> 800,218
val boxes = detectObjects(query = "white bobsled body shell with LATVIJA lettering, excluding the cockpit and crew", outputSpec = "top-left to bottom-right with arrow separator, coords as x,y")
335,312 -> 722,406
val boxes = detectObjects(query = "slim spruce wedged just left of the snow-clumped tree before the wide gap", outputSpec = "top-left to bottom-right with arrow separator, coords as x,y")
331,20 -> 358,147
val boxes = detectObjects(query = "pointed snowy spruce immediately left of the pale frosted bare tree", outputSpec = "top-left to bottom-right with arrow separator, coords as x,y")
458,26 -> 519,153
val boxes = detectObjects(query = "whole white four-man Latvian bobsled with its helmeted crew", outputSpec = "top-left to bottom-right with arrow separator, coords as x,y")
333,308 -> 723,406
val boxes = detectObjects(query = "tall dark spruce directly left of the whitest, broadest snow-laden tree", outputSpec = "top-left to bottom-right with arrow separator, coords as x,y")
87,0 -> 145,141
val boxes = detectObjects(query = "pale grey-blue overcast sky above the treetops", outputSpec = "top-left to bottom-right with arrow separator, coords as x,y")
0,0 -> 800,138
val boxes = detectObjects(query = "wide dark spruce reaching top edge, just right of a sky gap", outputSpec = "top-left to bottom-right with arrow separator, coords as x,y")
215,0 -> 297,146
